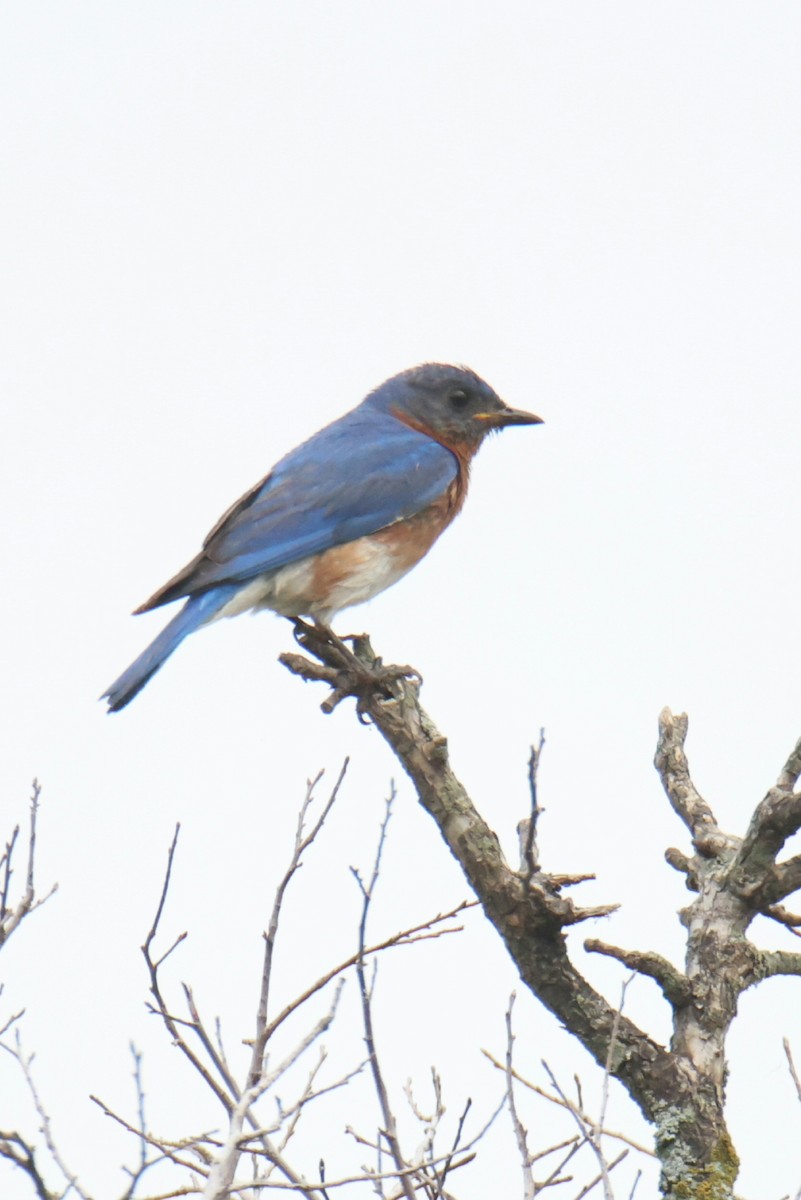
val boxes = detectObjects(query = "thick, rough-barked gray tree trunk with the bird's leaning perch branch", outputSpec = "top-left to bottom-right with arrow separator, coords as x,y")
282,624 -> 801,1200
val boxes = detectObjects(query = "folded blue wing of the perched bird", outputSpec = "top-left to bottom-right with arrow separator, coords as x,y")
139,406 -> 459,611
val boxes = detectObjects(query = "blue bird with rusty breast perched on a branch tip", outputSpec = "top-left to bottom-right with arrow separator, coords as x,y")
101,362 -> 542,713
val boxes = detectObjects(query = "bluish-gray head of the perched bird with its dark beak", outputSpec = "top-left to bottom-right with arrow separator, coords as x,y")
366,362 -> 542,452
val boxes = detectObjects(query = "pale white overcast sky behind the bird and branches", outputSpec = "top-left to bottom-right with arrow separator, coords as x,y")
0,0 -> 801,1200
